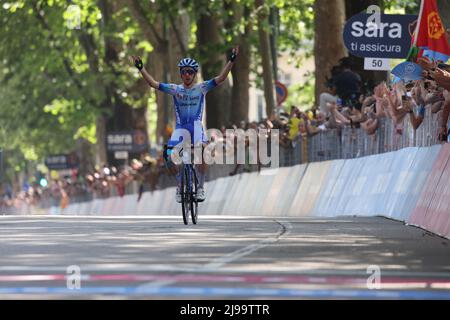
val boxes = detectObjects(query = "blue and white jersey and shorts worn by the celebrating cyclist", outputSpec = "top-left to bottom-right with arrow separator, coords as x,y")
158,79 -> 217,147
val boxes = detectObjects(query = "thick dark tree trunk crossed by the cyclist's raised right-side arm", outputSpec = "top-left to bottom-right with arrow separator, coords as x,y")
197,12 -> 231,129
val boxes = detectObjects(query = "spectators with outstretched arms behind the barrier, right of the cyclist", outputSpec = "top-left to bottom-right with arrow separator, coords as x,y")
262,54 -> 450,147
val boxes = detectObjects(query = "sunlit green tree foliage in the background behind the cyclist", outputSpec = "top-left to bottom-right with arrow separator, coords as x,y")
0,0 -> 418,184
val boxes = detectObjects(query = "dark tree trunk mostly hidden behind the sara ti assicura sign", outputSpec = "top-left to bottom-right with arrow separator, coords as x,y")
345,0 -> 388,88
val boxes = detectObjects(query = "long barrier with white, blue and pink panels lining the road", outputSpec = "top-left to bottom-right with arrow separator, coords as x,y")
9,144 -> 450,238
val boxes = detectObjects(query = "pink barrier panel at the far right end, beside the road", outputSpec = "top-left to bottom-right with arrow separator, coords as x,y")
407,144 -> 450,237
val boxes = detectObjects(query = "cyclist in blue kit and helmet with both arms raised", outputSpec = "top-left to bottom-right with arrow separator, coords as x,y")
131,47 -> 239,203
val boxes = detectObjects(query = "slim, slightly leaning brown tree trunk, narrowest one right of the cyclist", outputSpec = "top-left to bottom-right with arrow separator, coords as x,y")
255,0 -> 275,117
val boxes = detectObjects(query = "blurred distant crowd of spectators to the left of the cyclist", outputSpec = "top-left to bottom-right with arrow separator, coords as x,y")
0,155 -> 163,213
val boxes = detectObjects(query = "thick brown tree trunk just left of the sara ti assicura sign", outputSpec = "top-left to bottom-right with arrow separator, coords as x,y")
314,0 -> 347,105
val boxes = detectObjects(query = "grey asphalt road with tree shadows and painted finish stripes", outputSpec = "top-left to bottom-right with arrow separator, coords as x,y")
0,216 -> 450,299
